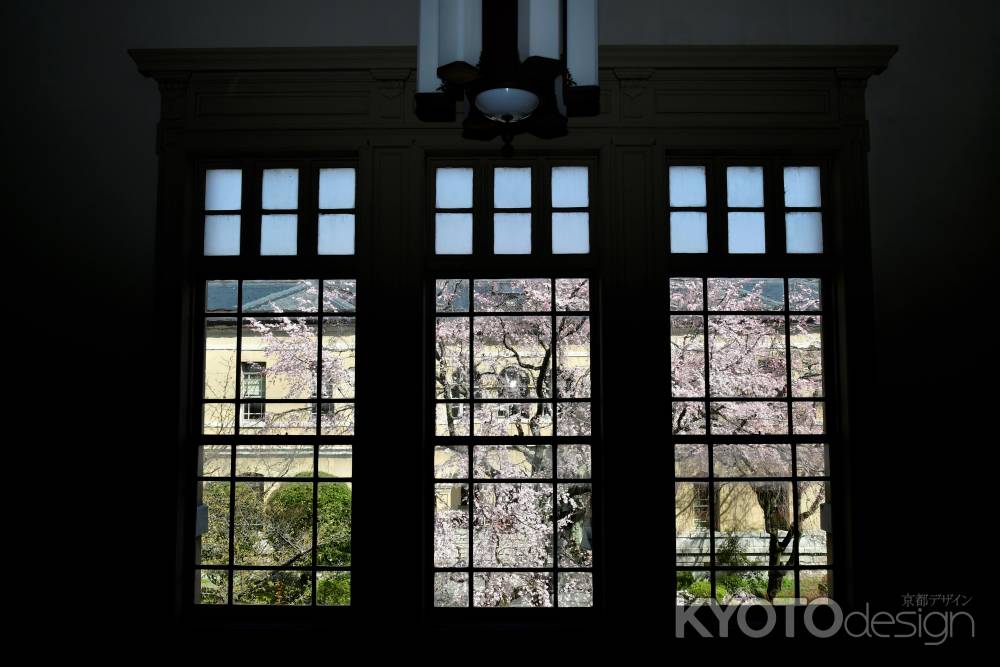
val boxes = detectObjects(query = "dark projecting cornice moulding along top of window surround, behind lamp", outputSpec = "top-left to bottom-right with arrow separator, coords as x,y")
129,45 -> 897,79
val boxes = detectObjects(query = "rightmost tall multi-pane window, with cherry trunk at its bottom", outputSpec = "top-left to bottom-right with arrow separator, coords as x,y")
667,160 -> 836,604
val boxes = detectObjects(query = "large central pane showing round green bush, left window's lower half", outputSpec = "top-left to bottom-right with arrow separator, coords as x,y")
234,481 -> 313,566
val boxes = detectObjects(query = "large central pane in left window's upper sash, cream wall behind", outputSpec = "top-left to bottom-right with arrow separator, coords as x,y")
240,317 -> 318,399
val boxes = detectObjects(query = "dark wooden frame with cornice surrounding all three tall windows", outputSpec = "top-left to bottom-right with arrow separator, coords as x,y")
132,46 -> 895,627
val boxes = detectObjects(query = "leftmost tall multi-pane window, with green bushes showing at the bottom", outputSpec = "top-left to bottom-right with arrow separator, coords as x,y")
192,161 -> 357,606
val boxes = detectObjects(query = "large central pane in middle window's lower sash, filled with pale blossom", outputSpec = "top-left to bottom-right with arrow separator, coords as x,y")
472,483 -> 552,567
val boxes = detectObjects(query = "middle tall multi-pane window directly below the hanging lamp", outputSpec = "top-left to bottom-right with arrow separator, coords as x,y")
429,159 -> 599,607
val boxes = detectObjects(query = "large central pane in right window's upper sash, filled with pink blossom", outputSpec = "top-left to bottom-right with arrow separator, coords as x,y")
708,315 -> 788,398
